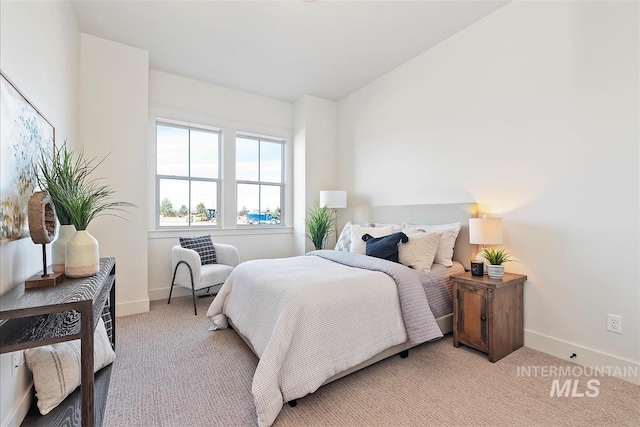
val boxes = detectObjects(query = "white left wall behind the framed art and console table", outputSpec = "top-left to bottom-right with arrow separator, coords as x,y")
0,1 -> 80,426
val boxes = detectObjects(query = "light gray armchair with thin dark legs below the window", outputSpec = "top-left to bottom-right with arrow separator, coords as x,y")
167,243 -> 240,315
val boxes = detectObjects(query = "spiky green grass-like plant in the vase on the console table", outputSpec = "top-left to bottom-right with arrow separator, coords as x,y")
37,141 -> 135,230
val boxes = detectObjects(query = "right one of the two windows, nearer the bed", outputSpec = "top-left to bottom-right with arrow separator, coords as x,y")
236,136 -> 284,225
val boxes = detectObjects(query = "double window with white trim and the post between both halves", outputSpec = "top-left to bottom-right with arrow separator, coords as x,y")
149,115 -> 291,234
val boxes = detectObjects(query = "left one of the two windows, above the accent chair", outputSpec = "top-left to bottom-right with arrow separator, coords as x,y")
156,122 -> 220,227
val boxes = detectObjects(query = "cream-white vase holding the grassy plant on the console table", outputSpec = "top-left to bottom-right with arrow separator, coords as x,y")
64,230 -> 100,277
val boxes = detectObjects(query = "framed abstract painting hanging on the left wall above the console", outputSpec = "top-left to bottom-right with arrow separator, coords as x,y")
0,71 -> 55,242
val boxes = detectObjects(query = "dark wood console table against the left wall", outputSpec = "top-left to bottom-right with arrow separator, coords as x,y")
0,258 -> 116,427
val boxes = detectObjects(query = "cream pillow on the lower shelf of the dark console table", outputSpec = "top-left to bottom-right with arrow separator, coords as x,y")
24,318 -> 116,415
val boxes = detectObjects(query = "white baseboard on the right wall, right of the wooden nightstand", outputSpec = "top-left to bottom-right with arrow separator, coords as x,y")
524,329 -> 640,385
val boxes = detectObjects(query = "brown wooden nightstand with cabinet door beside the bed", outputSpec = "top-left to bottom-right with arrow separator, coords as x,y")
451,272 -> 527,362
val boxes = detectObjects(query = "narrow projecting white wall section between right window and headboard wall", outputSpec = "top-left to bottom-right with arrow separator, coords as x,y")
293,95 -> 339,255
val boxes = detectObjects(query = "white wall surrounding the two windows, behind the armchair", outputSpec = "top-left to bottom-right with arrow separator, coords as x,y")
147,70 -> 294,300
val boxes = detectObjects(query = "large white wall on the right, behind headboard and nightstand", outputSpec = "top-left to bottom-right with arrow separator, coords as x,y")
338,2 -> 640,382
